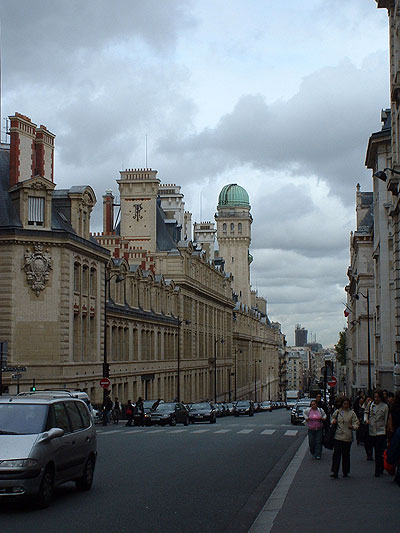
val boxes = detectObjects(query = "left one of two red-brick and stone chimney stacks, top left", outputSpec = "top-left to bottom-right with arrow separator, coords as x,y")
9,113 -> 36,187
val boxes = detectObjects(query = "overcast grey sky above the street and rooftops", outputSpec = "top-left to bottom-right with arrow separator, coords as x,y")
0,0 -> 389,346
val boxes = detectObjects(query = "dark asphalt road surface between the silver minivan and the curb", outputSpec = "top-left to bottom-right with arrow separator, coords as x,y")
0,410 -> 305,533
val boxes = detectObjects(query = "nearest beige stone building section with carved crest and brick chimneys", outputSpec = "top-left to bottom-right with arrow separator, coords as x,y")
0,113 -> 109,392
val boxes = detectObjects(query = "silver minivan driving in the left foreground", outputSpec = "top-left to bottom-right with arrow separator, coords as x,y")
0,392 -> 97,507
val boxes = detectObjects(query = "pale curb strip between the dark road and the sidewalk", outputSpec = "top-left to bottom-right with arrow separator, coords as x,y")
249,437 -> 308,533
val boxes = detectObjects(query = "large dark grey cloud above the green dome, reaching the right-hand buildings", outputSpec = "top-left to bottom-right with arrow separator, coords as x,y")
159,54 -> 387,202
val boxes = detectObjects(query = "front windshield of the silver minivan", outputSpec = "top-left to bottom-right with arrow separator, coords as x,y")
0,402 -> 48,435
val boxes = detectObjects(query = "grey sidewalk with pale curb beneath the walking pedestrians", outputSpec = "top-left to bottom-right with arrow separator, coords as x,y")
252,436 -> 400,533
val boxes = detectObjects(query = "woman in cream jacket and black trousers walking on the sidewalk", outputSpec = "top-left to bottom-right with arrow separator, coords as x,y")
331,397 -> 360,479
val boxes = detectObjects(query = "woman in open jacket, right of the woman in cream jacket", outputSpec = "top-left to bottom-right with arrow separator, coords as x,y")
364,390 -> 389,477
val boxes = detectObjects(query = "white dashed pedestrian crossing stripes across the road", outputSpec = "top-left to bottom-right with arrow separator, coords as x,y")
96,426 -> 303,437
